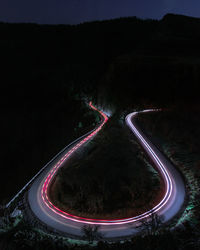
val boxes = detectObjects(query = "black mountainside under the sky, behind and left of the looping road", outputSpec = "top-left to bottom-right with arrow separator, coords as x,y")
0,15 -> 200,201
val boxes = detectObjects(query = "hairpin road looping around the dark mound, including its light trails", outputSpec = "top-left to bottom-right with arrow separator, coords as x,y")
28,102 -> 185,238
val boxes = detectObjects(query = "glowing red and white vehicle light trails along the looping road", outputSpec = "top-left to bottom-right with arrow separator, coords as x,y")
41,102 -> 173,225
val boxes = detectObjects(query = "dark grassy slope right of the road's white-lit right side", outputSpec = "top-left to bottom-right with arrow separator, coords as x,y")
138,104 -> 200,238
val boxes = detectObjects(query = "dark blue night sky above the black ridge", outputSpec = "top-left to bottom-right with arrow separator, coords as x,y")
0,0 -> 200,24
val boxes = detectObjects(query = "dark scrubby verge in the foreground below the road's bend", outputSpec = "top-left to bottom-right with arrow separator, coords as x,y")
0,213 -> 200,250
